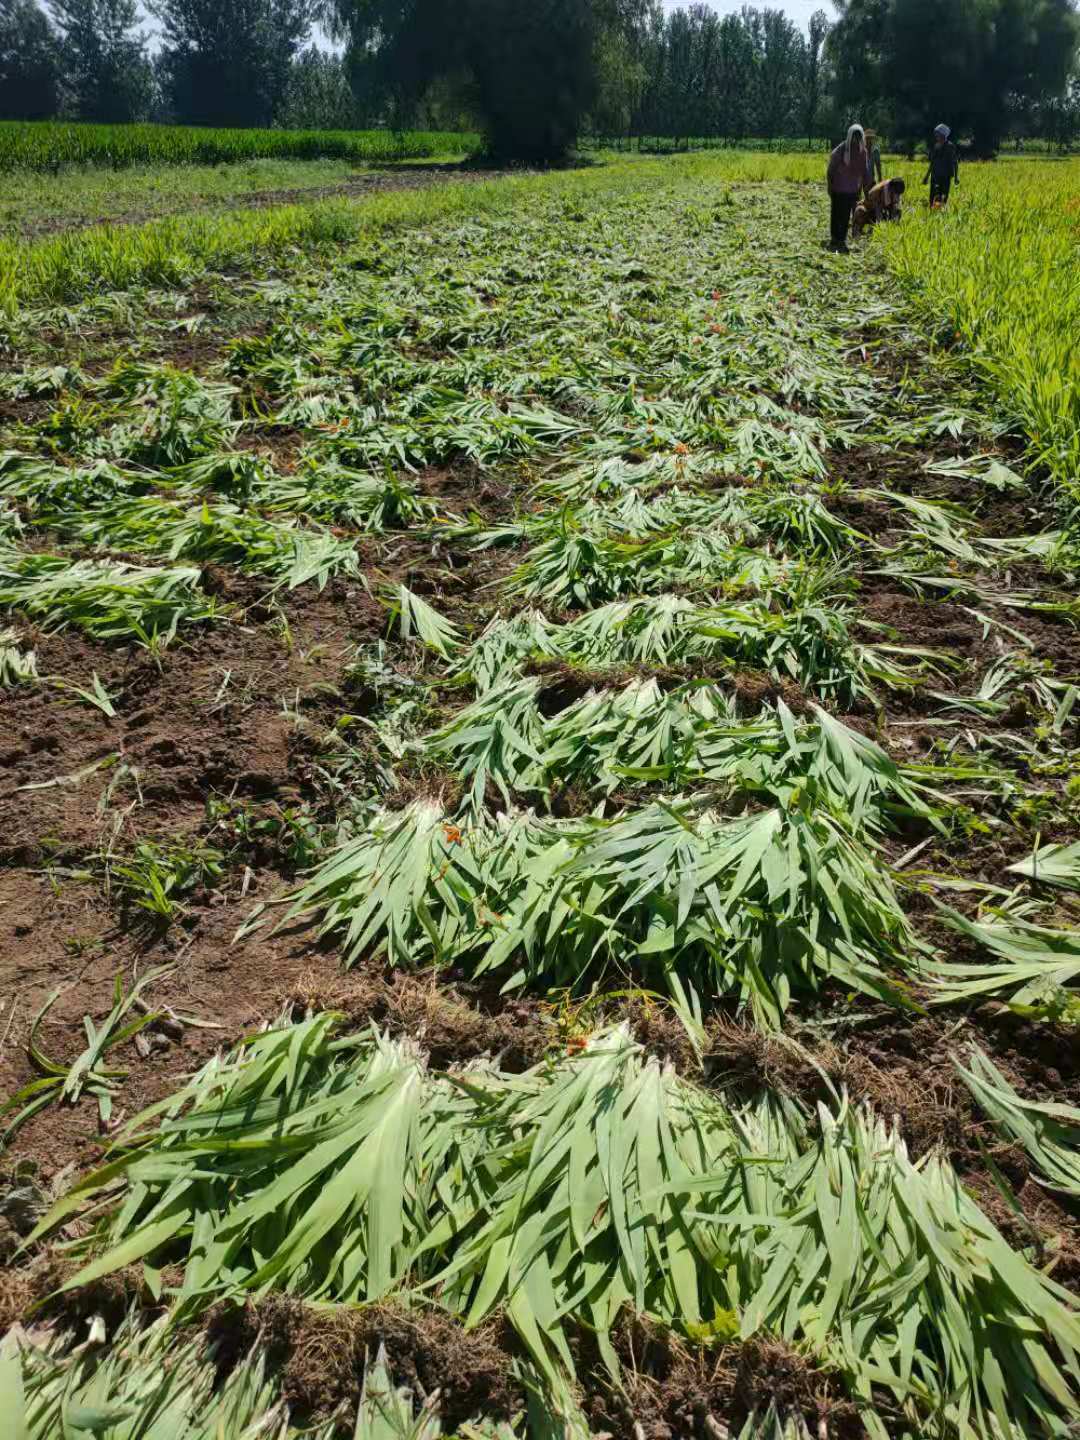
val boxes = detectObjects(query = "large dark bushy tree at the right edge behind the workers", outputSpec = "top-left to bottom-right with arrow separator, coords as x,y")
828,0 -> 1077,154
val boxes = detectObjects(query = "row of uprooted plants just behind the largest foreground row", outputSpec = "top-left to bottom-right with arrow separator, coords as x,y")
249,791 -> 923,1028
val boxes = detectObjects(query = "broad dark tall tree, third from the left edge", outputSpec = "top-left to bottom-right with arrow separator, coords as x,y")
154,0 -> 317,125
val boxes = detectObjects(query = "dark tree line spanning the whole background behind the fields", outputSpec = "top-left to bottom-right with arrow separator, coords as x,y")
0,0 -> 1080,158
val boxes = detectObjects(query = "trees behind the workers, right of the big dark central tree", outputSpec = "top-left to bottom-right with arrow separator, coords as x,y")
595,0 -> 1080,154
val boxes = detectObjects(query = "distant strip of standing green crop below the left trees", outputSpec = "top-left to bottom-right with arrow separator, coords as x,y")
0,121 -> 477,171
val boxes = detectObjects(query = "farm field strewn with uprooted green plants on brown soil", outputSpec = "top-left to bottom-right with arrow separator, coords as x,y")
0,156 -> 1080,1440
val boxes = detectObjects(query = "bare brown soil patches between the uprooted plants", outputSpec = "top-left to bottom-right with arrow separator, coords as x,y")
0,420 -> 1080,1221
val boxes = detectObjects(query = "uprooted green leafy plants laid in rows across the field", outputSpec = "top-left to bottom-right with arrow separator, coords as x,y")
0,166 -> 1080,1440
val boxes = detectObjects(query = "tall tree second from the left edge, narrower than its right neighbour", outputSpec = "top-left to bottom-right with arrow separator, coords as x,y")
48,0 -> 151,124
